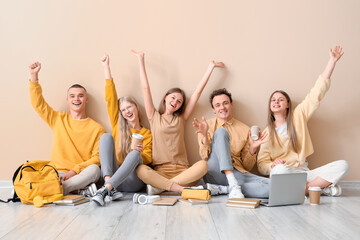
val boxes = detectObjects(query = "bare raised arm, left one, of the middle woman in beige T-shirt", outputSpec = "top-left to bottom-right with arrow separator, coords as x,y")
131,50 -> 155,119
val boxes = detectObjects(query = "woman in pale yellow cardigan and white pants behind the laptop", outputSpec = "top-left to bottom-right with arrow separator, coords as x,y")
257,46 -> 349,196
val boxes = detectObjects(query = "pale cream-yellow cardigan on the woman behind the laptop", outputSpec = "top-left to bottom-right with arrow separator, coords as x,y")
257,76 -> 331,175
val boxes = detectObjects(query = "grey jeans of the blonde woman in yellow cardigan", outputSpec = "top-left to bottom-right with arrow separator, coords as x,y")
99,133 -> 145,192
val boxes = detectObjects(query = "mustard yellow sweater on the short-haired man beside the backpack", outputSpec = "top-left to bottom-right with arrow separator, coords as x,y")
29,81 -> 104,173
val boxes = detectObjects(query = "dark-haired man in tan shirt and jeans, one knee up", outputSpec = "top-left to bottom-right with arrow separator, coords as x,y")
193,88 -> 269,198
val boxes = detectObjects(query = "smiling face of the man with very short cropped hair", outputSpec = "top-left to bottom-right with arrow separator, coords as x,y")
66,88 -> 88,113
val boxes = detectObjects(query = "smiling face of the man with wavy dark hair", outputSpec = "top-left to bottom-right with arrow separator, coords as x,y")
212,94 -> 233,122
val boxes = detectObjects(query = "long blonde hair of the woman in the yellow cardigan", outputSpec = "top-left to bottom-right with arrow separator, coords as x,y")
118,96 -> 142,160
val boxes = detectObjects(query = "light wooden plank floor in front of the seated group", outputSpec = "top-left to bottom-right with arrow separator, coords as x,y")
0,182 -> 360,240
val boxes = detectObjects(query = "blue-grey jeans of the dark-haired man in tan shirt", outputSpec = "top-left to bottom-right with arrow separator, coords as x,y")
204,128 -> 270,198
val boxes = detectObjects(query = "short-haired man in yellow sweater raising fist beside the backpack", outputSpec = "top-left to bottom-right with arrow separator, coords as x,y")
29,62 -> 104,195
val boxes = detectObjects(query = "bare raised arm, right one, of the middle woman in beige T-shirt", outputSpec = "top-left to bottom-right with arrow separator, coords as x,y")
184,61 -> 225,120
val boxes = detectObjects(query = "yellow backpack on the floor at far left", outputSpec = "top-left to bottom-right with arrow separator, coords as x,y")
13,160 -> 63,207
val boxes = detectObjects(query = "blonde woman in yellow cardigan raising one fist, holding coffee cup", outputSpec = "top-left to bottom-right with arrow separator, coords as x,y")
93,54 -> 152,206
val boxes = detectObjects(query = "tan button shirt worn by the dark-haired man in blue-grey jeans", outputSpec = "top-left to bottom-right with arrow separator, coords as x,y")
198,118 -> 256,172
